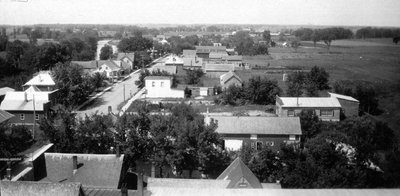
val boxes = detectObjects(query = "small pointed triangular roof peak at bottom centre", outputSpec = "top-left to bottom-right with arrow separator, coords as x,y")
217,157 -> 262,188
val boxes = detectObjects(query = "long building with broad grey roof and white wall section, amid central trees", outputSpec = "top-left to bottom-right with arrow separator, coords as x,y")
205,116 -> 302,150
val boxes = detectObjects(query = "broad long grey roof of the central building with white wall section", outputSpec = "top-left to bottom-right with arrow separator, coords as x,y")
210,116 -> 301,135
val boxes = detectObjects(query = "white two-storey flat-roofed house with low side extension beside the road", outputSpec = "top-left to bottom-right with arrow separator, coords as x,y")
144,76 -> 185,98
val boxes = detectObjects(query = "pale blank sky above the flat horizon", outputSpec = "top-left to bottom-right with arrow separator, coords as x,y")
0,0 -> 400,27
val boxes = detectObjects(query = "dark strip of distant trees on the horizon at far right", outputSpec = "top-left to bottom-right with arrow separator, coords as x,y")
356,27 -> 400,39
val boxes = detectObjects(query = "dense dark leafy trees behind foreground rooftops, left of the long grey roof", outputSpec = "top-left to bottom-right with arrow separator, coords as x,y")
40,102 -> 230,177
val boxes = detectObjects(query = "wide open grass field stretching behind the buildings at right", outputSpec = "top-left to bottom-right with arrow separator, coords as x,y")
239,39 -> 400,135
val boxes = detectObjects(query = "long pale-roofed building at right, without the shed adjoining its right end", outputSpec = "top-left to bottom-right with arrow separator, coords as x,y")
276,96 -> 342,121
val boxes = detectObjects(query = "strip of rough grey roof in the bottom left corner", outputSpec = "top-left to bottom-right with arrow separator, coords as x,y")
0,181 -> 82,196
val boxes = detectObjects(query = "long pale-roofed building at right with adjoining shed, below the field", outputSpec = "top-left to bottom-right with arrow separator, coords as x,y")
276,93 -> 359,121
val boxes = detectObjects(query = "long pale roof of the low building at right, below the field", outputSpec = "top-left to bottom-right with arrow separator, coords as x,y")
276,96 -> 341,108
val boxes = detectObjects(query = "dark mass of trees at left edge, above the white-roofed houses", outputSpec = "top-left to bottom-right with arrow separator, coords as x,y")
0,29 -> 98,89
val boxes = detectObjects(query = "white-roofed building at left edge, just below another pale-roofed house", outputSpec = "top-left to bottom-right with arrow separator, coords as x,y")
0,86 -> 57,130
